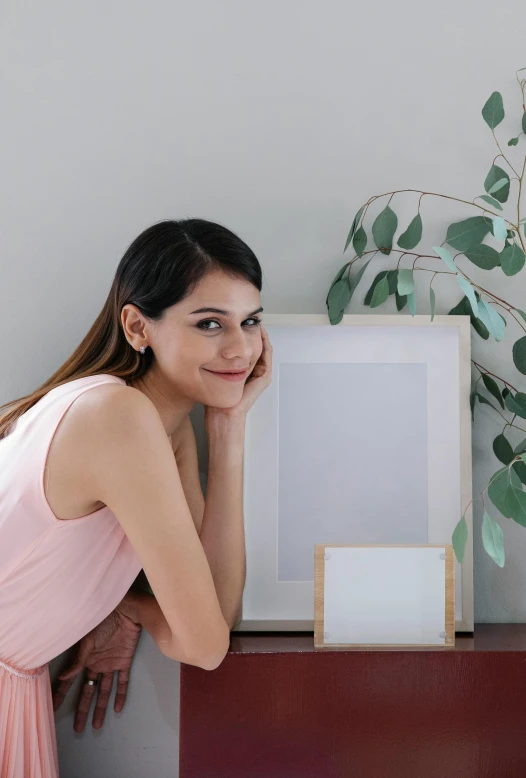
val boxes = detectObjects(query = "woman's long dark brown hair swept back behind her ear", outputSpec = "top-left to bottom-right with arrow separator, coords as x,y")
0,218 -> 262,438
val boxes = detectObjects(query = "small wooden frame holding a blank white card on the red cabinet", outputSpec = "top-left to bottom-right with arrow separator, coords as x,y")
314,544 -> 455,649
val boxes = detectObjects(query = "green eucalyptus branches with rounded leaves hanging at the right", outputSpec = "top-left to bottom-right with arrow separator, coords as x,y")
326,68 -> 526,567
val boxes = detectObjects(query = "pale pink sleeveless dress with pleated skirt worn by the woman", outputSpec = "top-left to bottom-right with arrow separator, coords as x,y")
0,373 -> 142,778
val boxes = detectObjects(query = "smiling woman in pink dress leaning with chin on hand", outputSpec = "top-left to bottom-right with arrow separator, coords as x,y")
0,219 -> 272,778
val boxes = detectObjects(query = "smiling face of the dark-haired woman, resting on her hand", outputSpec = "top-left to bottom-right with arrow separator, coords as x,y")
145,271 -> 263,408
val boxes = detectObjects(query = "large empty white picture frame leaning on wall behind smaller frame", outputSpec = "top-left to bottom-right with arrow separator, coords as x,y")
236,314 -> 473,631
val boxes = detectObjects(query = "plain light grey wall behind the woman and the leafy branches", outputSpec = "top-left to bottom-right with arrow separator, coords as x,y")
0,0 -> 526,778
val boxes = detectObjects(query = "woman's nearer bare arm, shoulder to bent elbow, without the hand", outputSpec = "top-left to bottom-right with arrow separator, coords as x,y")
86,388 -> 230,669
